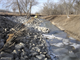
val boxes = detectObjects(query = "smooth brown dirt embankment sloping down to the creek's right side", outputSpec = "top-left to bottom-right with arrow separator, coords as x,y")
43,15 -> 80,41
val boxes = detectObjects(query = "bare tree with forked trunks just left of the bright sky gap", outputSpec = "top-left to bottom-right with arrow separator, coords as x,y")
19,0 -> 38,18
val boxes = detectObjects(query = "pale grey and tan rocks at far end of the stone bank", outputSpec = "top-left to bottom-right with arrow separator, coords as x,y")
6,16 -> 50,33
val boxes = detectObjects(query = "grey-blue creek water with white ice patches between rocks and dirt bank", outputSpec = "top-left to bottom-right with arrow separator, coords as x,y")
40,19 -> 80,60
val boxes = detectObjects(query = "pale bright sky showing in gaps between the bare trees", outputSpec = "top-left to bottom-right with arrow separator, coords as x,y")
0,0 -> 58,13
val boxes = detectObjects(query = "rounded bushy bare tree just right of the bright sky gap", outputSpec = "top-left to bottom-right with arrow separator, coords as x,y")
41,1 -> 64,15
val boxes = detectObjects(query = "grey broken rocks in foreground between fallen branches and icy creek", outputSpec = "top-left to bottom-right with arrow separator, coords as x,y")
0,27 -> 51,60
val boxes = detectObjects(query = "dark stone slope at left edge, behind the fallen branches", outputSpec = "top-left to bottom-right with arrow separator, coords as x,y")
0,16 -> 16,49
